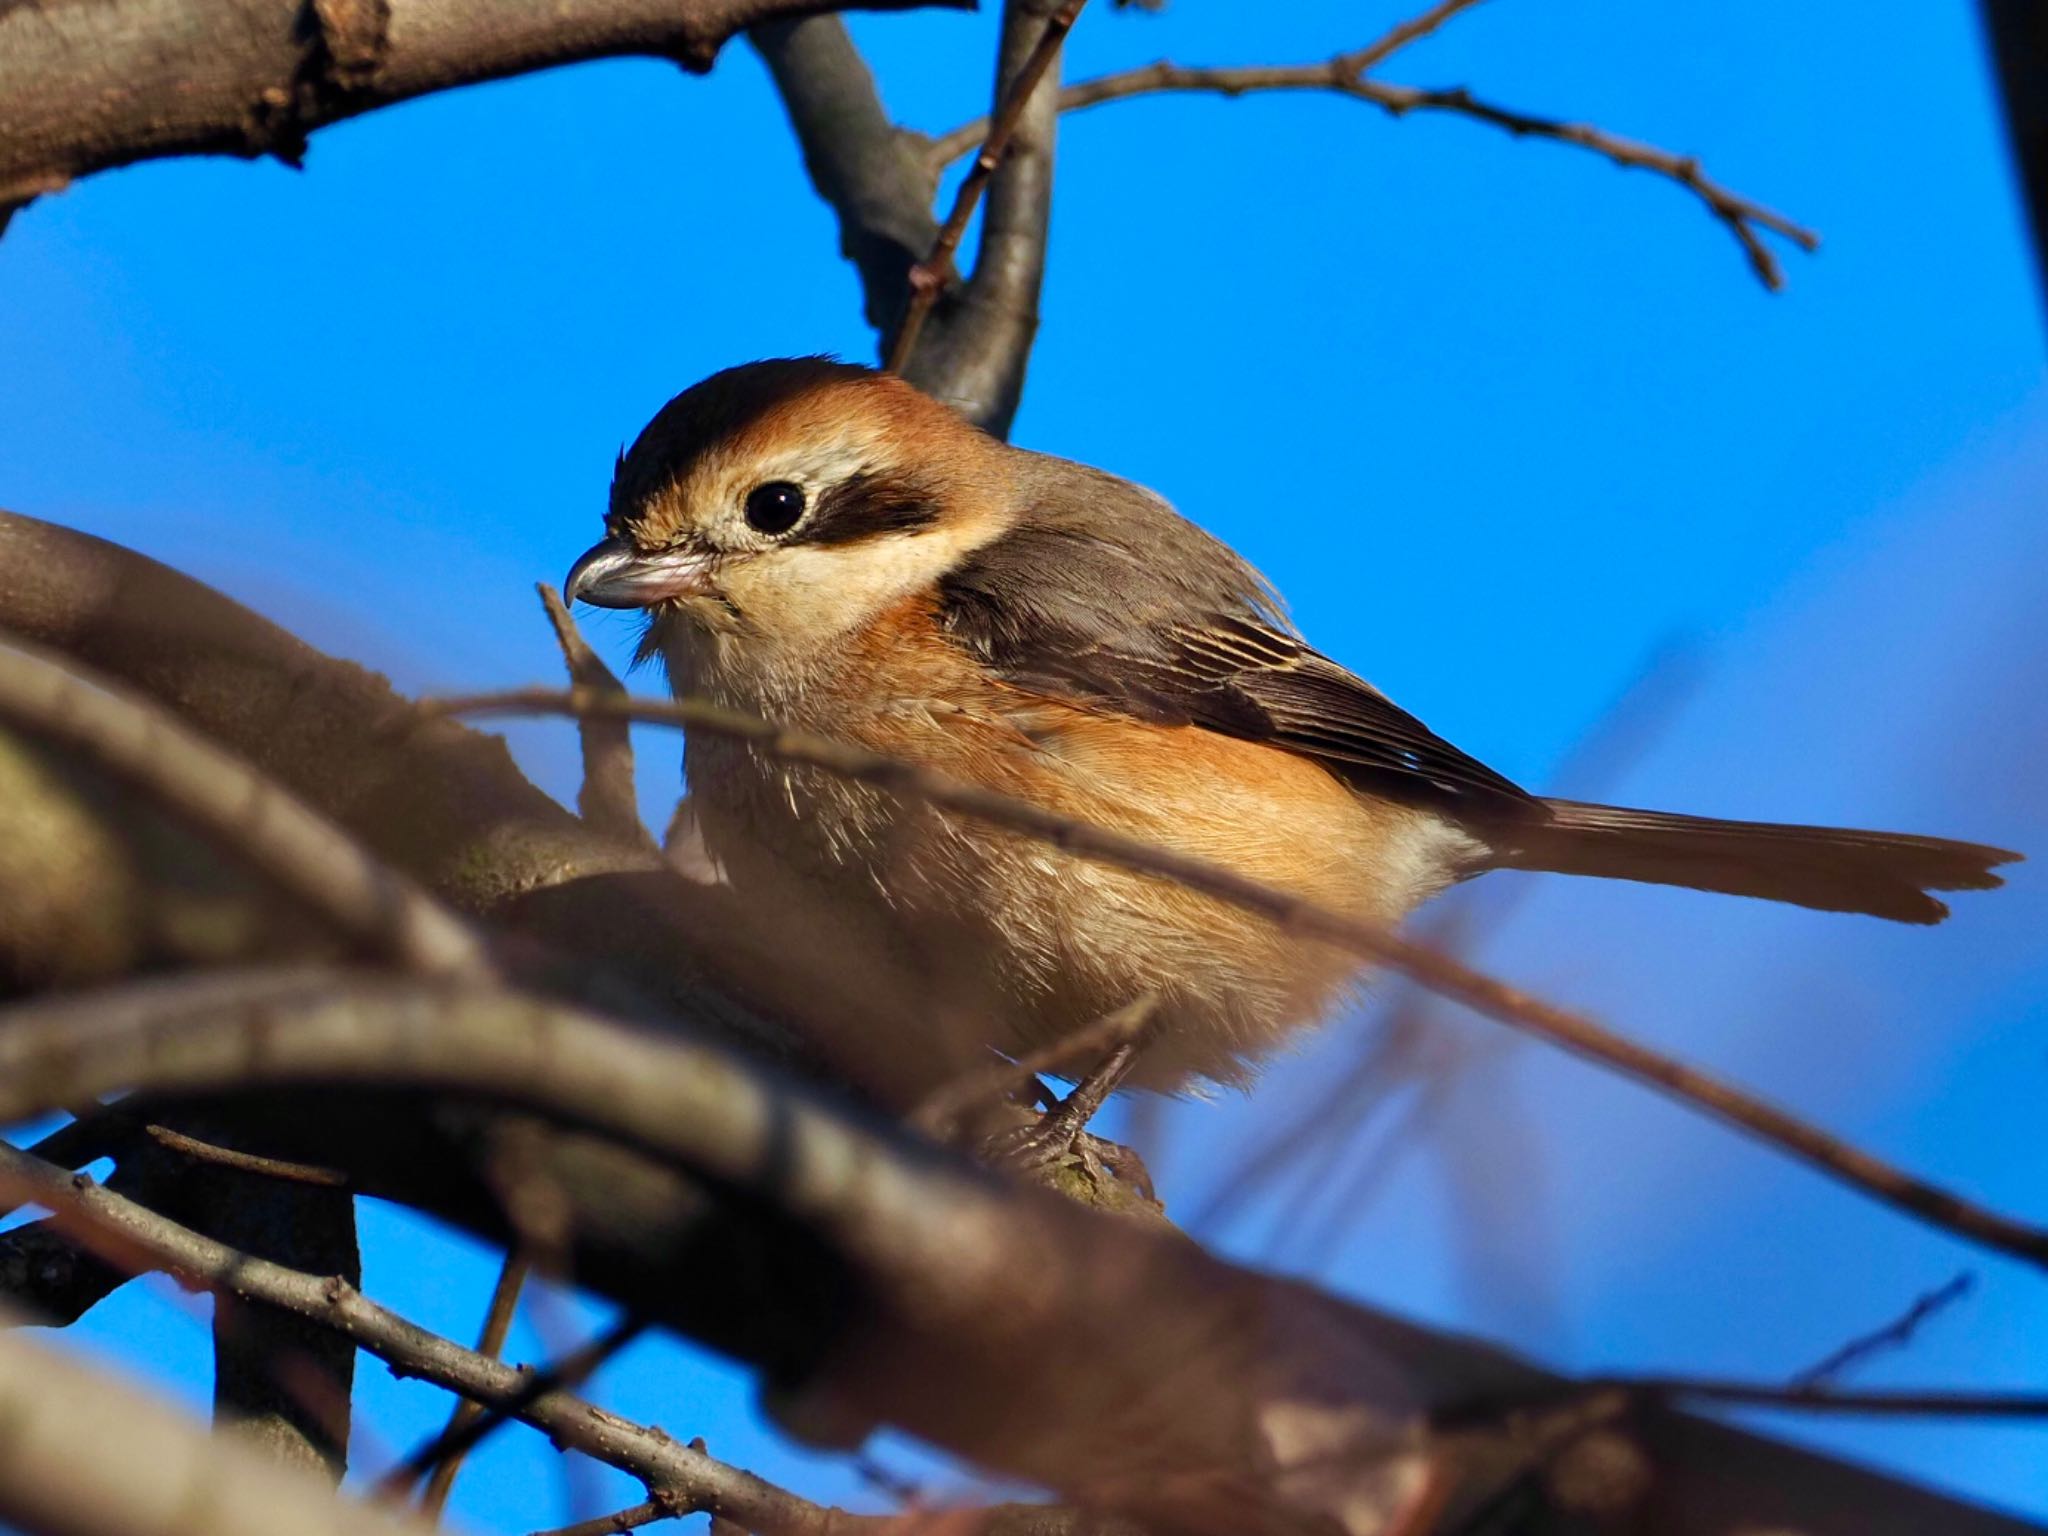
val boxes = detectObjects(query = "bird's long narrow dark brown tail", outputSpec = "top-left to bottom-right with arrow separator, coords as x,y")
1493,801 -> 2019,924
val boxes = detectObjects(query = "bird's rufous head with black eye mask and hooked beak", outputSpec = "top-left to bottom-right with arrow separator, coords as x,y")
563,358 -> 1008,671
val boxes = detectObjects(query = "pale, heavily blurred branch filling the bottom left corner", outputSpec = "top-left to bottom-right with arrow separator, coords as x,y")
0,1335 -> 428,1536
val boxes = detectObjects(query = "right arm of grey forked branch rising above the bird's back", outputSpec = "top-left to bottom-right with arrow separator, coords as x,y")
887,0 -> 1083,436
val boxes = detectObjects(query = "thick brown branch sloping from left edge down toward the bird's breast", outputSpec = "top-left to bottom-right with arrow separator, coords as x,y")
0,512 -> 817,1061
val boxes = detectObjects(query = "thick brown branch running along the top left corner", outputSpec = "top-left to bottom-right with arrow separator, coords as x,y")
0,0 -> 973,224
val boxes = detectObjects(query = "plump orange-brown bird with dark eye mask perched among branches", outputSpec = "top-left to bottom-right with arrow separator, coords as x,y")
563,356 -> 2019,1094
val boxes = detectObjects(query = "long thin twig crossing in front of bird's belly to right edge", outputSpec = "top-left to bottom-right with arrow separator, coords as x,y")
422,688 -> 2048,1268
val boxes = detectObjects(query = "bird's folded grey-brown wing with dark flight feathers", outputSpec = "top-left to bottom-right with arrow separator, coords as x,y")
940,477 -> 1544,825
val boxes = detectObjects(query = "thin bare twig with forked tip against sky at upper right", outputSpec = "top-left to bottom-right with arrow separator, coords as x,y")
930,45 -> 1821,293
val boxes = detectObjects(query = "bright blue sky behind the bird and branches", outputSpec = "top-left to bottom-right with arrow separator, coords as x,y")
0,0 -> 2048,1530
